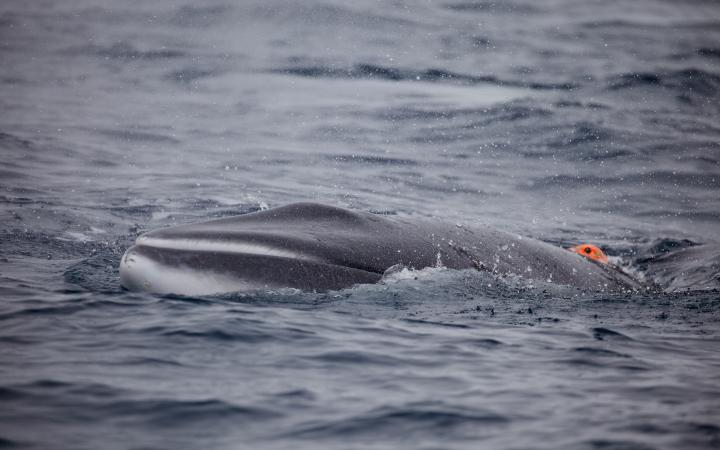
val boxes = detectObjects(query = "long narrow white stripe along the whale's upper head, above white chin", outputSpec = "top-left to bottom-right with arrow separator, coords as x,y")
137,236 -> 325,262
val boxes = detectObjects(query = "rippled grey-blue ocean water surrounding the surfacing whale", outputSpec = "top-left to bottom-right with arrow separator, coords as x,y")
0,0 -> 720,449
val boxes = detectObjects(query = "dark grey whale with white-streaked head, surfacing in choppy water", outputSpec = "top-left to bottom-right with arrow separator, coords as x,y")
120,203 -> 639,295
